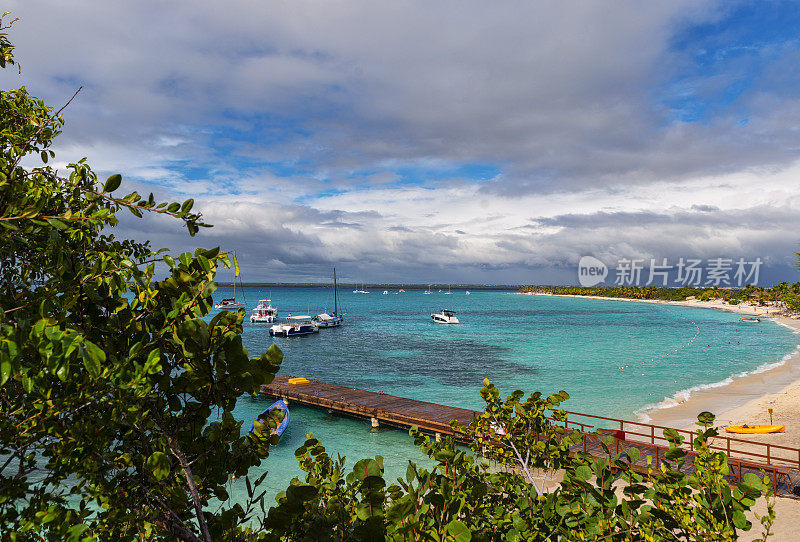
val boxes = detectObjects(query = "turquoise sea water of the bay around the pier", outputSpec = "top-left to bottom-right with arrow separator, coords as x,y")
215,287 -> 798,508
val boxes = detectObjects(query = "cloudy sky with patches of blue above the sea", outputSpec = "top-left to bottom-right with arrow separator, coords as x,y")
0,0 -> 800,284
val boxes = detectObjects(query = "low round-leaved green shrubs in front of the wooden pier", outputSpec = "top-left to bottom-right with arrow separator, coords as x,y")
258,381 -> 775,542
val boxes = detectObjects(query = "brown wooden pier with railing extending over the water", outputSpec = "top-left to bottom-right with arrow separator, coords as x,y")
261,376 -> 800,496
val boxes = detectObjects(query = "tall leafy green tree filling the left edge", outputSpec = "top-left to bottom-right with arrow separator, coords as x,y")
0,20 -> 282,541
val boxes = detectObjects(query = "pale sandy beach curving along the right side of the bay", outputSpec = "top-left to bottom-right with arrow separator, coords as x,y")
521,293 -> 800,447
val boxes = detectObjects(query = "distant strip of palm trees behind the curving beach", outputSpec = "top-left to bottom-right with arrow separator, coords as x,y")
519,282 -> 800,310
